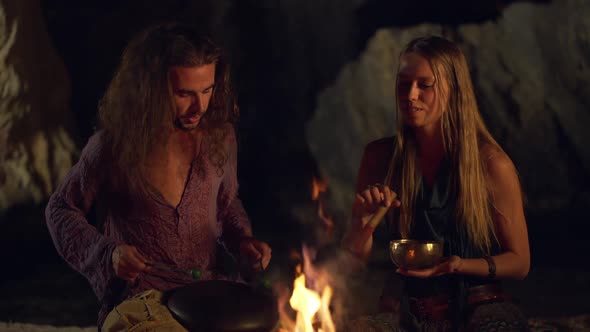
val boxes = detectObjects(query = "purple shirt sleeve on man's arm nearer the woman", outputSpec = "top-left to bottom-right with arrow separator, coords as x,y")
217,127 -> 252,254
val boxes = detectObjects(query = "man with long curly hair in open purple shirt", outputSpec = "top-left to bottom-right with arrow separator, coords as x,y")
46,24 -> 271,330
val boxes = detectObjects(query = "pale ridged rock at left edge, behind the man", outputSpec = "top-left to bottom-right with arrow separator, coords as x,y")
0,0 -> 76,213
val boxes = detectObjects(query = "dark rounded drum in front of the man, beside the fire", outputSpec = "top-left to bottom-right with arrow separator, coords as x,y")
166,280 -> 279,332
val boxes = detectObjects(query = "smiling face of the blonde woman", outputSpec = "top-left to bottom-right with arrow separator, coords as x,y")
397,53 -> 443,131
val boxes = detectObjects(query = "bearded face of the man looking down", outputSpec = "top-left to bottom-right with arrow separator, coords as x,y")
170,64 -> 215,130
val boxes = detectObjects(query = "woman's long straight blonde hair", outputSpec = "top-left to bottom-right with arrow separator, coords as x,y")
385,37 -> 502,253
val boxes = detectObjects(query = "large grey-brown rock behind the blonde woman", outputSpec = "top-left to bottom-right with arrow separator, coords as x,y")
307,0 -> 590,220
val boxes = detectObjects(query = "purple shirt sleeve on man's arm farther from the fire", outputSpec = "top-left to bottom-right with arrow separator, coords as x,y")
45,134 -> 118,300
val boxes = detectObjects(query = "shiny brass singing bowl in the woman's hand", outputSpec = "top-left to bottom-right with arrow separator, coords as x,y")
389,239 -> 443,270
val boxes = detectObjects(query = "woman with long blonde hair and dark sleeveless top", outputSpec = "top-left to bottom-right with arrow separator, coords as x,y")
345,37 -> 530,331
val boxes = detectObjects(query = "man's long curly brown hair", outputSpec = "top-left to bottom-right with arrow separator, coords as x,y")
99,23 -> 238,188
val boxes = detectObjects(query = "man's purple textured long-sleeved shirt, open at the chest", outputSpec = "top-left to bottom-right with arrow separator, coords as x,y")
45,128 -> 252,326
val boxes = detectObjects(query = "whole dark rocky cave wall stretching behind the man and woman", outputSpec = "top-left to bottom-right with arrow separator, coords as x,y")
0,0 -> 590,241
